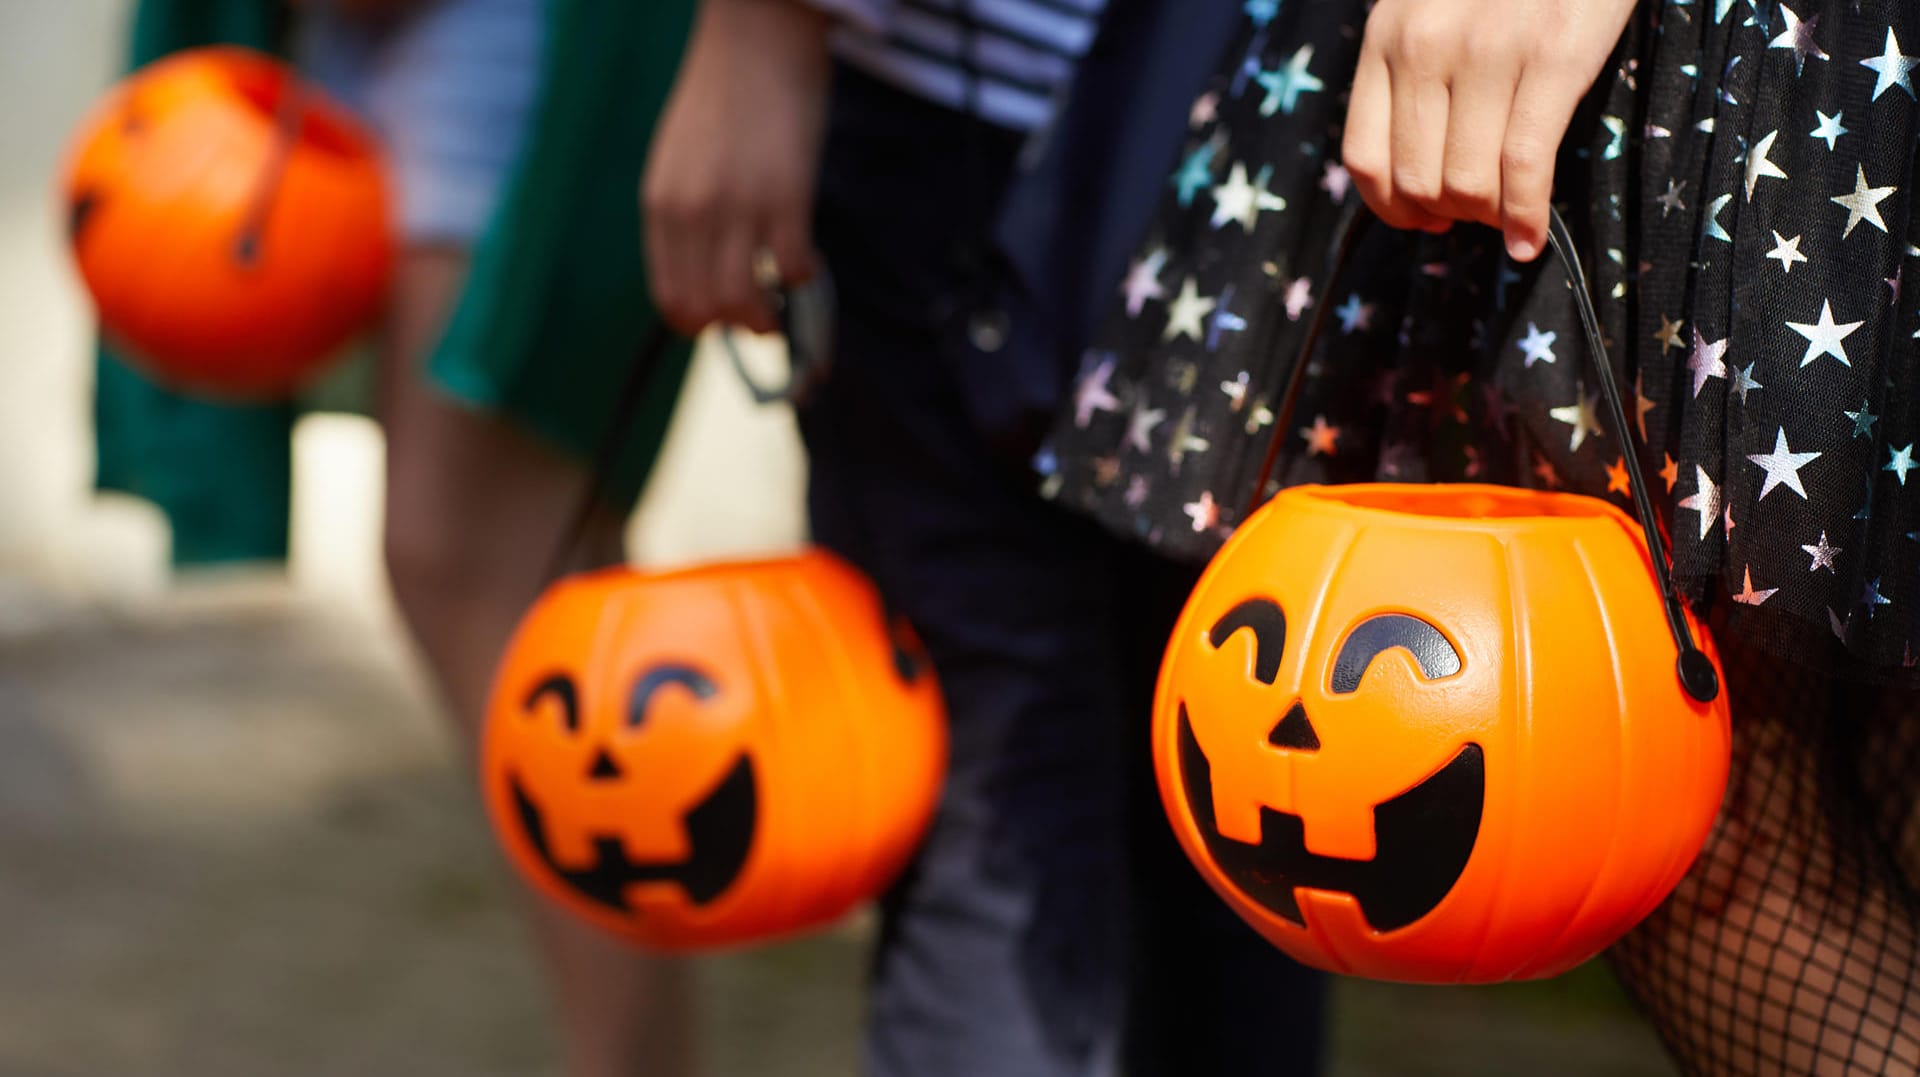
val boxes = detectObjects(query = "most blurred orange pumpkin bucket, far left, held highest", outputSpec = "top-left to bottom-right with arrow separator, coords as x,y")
63,46 -> 394,397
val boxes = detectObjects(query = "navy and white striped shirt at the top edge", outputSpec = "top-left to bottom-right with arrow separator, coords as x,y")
810,0 -> 1106,131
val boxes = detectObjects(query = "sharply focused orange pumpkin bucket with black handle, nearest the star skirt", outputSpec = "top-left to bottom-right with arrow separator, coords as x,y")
1152,208 -> 1730,983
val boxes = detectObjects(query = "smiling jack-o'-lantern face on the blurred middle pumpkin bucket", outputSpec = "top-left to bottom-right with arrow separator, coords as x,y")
507,664 -> 758,914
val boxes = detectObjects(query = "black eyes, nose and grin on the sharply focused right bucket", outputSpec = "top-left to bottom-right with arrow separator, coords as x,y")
1179,599 -> 1486,931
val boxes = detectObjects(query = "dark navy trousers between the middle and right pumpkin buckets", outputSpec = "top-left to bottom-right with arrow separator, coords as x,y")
801,71 -> 1325,1077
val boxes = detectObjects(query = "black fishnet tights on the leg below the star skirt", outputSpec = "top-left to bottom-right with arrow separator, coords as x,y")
1611,639 -> 1920,1077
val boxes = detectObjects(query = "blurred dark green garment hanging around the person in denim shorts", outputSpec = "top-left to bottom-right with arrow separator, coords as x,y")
94,0 -> 693,564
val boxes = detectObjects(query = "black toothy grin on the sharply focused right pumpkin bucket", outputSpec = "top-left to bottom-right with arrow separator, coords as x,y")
1179,705 -> 1486,931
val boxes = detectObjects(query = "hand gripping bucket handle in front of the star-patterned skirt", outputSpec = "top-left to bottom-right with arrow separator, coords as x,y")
1342,0 -> 1636,261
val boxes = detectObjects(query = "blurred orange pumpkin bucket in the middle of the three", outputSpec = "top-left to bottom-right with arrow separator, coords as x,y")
480,551 -> 947,950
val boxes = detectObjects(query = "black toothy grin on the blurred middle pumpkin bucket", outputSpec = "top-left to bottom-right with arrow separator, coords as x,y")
507,754 -> 760,914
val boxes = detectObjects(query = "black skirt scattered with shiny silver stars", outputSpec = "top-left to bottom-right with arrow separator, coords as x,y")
1039,0 -> 1920,672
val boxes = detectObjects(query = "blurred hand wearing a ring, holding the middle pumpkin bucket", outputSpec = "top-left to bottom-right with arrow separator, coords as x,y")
628,0 -> 829,336
